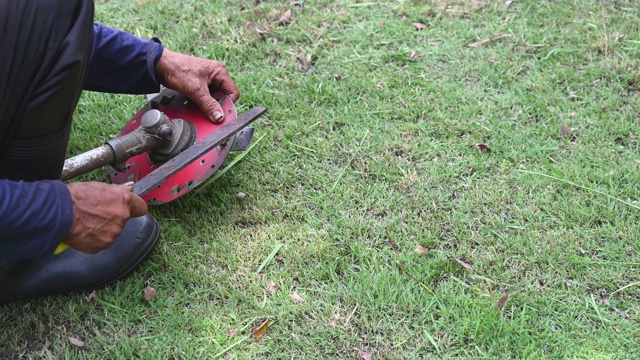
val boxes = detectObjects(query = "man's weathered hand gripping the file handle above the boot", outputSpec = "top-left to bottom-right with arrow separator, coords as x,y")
63,182 -> 148,254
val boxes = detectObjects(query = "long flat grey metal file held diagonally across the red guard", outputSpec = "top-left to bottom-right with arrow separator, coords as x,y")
133,107 -> 267,196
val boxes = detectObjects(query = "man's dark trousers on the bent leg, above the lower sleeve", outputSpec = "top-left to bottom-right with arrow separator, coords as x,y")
0,0 -> 94,181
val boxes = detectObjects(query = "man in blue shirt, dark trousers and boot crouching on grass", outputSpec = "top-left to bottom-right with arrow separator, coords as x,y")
0,0 -> 240,303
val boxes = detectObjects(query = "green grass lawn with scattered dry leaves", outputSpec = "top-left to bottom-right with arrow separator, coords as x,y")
0,0 -> 640,359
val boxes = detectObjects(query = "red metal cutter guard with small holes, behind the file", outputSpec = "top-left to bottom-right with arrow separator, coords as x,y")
109,89 -> 238,205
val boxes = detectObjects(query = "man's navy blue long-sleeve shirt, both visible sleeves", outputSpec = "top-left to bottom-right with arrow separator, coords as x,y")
0,24 -> 162,258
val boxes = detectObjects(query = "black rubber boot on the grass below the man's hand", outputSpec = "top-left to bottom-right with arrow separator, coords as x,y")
0,214 -> 160,304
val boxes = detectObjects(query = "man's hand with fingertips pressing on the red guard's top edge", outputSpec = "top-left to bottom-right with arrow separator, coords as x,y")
156,49 -> 240,123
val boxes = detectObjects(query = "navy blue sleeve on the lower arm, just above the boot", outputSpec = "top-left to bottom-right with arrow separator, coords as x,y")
0,179 -> 73,259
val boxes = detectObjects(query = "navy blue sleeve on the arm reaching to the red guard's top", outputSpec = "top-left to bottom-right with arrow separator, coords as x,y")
84,23 -> 163,94
